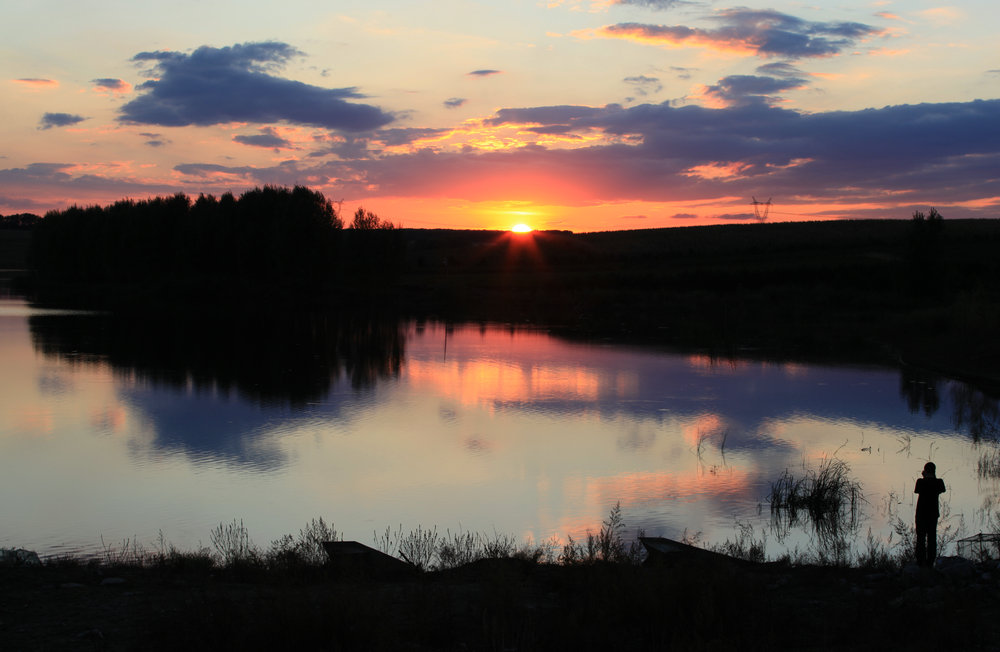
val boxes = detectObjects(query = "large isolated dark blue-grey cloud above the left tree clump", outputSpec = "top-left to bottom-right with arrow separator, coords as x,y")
119,42 -> 394,132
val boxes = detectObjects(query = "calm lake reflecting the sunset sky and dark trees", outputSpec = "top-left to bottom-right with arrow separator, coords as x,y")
0,298 -> 998,556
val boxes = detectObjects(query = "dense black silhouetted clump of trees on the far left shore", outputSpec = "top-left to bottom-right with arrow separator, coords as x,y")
29,186 -> 401,290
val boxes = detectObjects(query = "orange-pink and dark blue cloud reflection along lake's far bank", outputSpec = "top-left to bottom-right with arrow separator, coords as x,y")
404,327 -> 949,466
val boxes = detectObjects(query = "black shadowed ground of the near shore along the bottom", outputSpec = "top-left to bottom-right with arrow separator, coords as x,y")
0,560 -> 1000,651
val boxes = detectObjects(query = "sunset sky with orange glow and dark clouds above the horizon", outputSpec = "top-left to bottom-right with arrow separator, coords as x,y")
0,0 -> 1000,232
